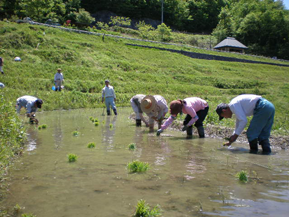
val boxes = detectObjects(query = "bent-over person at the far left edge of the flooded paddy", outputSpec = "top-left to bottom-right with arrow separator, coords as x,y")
16,96 -> 43,124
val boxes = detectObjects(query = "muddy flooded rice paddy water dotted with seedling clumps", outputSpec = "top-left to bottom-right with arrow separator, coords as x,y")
4,108 -> 289,217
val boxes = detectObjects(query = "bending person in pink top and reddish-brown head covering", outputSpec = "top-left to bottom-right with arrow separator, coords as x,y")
157,97 -> 209,138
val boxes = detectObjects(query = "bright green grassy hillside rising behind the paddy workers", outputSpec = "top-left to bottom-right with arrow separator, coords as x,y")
0,22 -> 289,134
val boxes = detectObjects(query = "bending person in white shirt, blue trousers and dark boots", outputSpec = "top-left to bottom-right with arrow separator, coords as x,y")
216,94 -> 275,154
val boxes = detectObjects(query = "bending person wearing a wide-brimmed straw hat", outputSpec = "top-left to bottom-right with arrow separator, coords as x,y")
141,95 -> 169,132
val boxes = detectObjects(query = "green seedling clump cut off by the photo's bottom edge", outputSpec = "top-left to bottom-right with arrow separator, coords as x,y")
133,200 -> 161,217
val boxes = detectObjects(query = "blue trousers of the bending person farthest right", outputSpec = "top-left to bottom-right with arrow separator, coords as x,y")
247,98 -> 275,142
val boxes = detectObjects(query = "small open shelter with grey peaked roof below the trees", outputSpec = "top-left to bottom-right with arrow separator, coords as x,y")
214,37 -> 248,53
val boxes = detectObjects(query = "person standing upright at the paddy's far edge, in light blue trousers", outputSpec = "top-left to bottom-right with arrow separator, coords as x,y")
101,80 -> 117,115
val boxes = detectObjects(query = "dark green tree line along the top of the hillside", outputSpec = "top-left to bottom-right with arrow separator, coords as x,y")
0,0 -> 289,59
